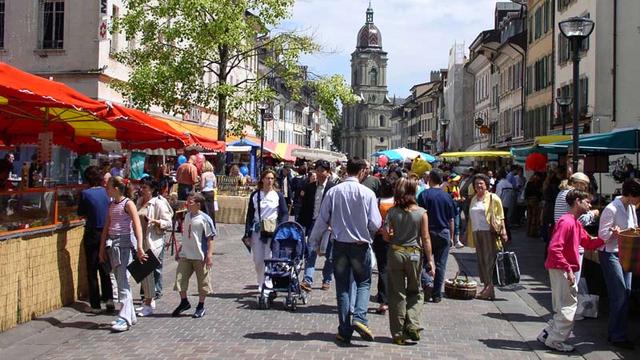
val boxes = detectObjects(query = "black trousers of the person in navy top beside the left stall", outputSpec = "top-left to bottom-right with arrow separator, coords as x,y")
82,227 -> 113,309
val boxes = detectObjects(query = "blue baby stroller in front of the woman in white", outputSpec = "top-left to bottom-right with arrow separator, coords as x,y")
258,221 -> 308,311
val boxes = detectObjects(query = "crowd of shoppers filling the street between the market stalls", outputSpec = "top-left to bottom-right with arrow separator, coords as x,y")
74,156 -> 640,352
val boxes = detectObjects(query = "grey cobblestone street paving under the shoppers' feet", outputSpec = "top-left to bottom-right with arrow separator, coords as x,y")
0,225 -> 637,360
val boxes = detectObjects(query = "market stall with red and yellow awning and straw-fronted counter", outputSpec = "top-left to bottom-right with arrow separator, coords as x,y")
0,62 -> 205,331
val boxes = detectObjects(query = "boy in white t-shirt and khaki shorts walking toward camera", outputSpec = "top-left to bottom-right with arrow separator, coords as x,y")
172,193 -> 216,318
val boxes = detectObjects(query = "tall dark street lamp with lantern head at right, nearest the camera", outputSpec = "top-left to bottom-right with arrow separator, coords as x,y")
558,17 -> 595,173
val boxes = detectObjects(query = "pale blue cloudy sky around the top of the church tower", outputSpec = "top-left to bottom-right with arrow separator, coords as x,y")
282,0 -> 496,98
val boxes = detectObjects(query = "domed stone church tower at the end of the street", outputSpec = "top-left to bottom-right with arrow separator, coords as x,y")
342,3 -> 393,159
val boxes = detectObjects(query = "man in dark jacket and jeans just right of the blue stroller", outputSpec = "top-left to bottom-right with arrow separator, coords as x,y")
298,160 -> 335,291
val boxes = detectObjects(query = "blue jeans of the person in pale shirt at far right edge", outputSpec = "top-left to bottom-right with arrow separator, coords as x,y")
598,251 -> 631,341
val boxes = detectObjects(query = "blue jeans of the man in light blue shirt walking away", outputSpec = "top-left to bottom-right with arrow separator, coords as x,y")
333,241 -> 371,339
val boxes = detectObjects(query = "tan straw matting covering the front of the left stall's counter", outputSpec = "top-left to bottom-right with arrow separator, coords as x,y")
0,226 -> 88,331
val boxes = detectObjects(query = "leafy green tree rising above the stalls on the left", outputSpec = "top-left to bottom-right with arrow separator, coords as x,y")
112,0 -> 354,160
